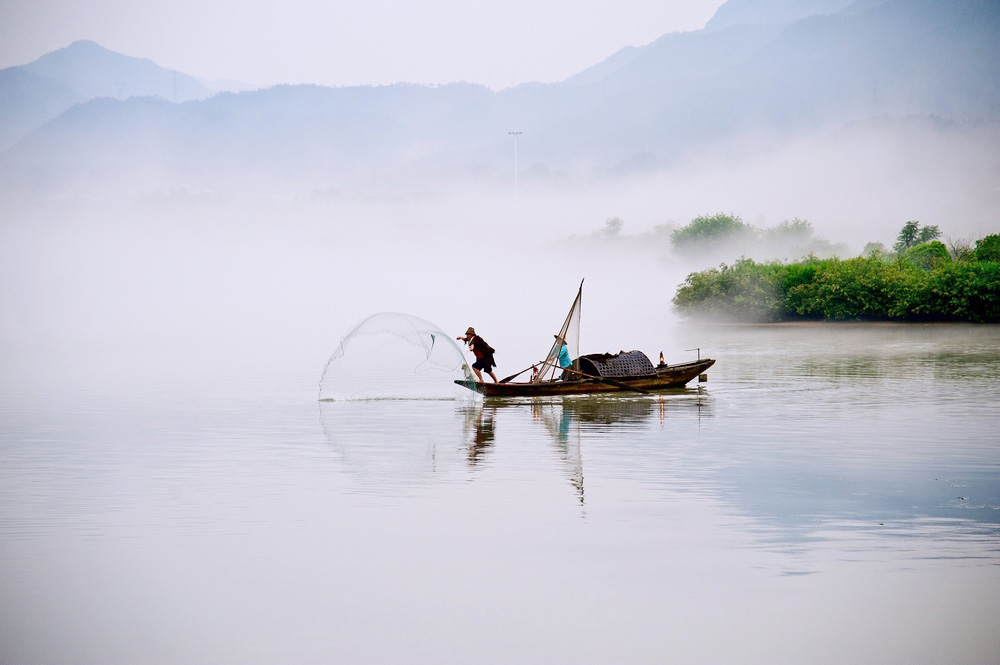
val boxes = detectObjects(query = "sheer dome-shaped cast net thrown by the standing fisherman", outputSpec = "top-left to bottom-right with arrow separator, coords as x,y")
319,312 -> 473,401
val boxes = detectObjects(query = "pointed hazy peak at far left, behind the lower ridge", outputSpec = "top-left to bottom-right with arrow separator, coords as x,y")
0,41 -> 214,150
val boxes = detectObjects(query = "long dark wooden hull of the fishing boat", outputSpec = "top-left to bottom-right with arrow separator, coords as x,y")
455,358 -> 715,397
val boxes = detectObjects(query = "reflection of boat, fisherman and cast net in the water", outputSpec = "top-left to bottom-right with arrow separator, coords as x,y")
320,387 -> 712,503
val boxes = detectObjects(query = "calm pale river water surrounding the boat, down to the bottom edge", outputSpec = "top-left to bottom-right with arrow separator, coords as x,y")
0,325 -> 1000,665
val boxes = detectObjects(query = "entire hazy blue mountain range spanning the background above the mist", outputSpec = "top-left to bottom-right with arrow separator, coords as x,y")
0,0 -> 1000,197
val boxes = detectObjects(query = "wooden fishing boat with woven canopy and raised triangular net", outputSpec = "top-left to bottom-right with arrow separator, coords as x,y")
455,282 -> 715,397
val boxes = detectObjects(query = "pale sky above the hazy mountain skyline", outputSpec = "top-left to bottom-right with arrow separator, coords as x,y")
0,0 -> 723,89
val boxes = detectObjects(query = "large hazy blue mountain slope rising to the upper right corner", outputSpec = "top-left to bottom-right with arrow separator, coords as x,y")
516,0 -> 1000,171
